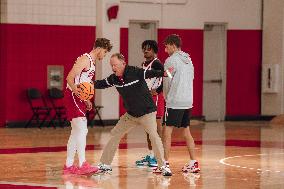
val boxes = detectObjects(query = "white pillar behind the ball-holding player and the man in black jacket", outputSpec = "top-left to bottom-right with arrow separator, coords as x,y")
95,0 -> 120,120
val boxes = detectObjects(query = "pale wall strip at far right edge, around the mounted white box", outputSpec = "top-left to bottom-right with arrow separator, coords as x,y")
261,0 -> 284,115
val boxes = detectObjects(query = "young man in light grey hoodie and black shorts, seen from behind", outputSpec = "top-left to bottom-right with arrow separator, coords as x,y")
163,34 -> 200,173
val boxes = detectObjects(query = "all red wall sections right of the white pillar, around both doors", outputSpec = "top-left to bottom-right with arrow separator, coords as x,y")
120,28 -> 262,116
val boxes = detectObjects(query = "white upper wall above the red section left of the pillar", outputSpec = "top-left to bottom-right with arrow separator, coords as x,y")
1,0 -> 96,26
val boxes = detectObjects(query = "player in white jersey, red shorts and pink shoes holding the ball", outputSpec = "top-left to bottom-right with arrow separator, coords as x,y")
63,38 -> 112,175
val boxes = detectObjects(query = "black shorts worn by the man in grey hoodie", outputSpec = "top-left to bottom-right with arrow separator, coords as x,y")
164,108 -> 191,128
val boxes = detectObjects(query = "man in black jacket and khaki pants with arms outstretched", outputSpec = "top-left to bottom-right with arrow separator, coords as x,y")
94,53 -> 172,176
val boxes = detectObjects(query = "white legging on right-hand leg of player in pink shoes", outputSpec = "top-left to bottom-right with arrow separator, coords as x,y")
72,117 -> 88,167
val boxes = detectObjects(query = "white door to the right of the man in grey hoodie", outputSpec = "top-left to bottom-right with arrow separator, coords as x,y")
203,24 -> 227,121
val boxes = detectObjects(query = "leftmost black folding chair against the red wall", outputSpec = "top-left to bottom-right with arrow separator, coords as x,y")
25,88 -> 51,128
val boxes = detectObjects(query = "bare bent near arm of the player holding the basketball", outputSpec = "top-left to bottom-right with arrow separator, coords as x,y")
66,56 -> 90,94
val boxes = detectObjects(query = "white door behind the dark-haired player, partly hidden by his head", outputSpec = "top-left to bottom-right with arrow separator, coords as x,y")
128,21 -> 157,67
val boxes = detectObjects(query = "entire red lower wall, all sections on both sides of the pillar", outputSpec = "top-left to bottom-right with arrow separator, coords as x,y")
0,24 -> 262,126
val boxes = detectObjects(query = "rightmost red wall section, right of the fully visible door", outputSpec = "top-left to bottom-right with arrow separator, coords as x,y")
226,30 -> 262,116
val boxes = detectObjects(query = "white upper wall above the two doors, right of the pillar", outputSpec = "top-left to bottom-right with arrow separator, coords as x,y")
120,0 -> 261,29
